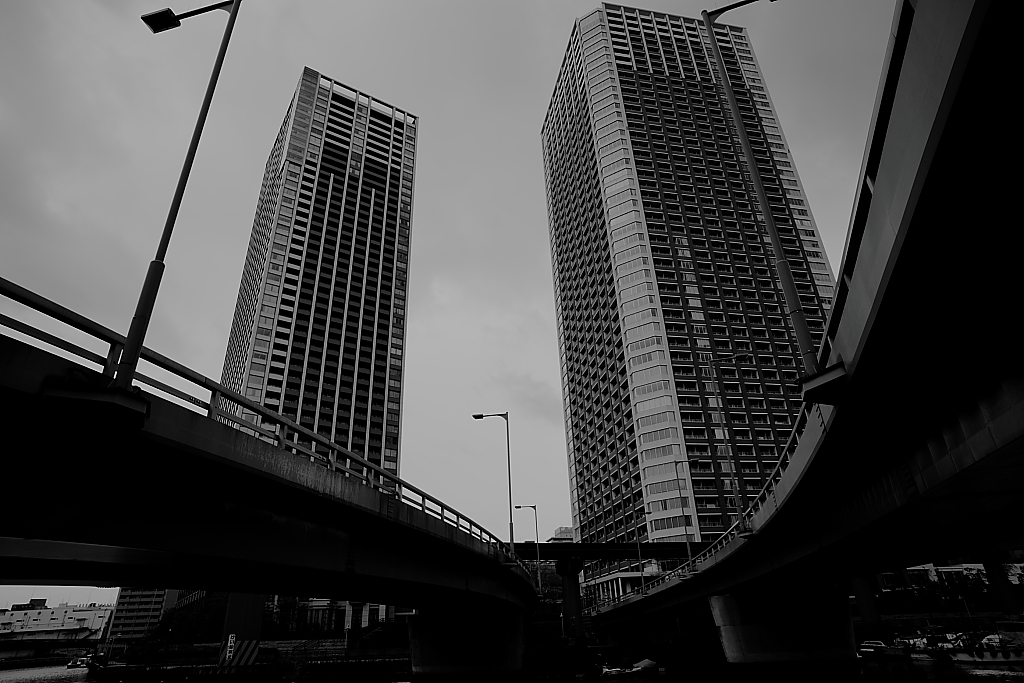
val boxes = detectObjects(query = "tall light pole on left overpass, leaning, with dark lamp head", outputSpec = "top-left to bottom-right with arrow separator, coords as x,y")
114,0 -> 242,389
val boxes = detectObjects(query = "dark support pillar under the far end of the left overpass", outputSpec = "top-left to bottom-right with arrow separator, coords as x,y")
409,603 -> 525,680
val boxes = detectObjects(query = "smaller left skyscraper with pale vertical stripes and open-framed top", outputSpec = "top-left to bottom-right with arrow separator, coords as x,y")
221,68 -> 418,473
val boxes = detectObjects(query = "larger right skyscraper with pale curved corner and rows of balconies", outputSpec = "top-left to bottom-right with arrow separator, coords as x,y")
542,4 -> 834,593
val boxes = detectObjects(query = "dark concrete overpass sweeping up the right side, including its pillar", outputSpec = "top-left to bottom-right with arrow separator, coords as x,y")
593,0 -> 1024,661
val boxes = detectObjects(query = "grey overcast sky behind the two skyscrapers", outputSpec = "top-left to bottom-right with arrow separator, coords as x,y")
0,0 -> 894,606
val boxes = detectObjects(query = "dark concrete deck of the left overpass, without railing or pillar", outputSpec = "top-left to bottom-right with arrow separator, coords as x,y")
0,337 -> 534,607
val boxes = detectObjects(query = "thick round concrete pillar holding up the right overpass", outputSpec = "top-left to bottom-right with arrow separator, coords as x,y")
709,586 -> 856,664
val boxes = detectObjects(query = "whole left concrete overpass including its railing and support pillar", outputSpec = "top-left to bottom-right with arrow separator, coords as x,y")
0,281 -> 536,673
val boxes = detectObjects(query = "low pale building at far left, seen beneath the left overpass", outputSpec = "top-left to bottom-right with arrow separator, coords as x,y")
0,598 -> 114,642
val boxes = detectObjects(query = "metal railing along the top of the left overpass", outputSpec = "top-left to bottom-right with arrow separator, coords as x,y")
0,278 -> 532,577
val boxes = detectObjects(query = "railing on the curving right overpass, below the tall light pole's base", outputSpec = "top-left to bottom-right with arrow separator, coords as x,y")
587,401 -> 813,614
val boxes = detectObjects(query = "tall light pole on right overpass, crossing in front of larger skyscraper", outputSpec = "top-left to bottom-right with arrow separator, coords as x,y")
700,0 -> 818,376
